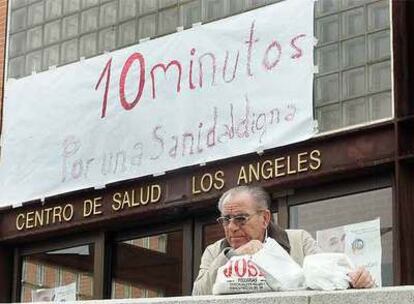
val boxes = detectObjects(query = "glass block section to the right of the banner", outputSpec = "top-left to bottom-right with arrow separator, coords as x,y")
314,0 -> 392,132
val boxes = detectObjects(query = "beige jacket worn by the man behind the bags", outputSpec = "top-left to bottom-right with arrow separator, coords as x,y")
193,229 -> 321,295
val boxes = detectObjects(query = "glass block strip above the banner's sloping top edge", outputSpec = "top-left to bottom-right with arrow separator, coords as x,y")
8,0 -> 280,78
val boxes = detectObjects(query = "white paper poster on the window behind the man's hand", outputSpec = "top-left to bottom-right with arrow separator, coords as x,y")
316,218 -> 382,286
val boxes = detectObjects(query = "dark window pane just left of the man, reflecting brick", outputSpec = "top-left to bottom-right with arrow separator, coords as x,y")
111,231 -> 183,299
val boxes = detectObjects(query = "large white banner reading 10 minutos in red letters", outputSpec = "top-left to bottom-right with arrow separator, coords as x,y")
0,0 -> 314,205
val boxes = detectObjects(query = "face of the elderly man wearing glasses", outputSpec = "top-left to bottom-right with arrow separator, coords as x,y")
222,192 -> 270,249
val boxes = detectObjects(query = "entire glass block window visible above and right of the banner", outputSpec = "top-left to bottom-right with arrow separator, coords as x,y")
8,0 -> 392,132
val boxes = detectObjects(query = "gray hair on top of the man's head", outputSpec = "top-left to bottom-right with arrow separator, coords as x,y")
217,186 -> 271,212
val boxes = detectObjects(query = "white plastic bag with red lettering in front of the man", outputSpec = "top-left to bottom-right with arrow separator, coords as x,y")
213,238 -> 305,294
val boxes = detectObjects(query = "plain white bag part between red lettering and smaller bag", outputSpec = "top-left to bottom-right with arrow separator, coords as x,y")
252,238 -> 305,291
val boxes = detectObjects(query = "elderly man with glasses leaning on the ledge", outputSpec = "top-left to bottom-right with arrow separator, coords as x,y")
193,186 -> 375,295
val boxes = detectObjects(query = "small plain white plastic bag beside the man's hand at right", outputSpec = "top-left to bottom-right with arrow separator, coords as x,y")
303,253 -> 354,290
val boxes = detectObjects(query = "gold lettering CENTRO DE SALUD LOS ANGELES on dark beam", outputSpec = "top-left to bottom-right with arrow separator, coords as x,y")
10,150 -> 322,231
